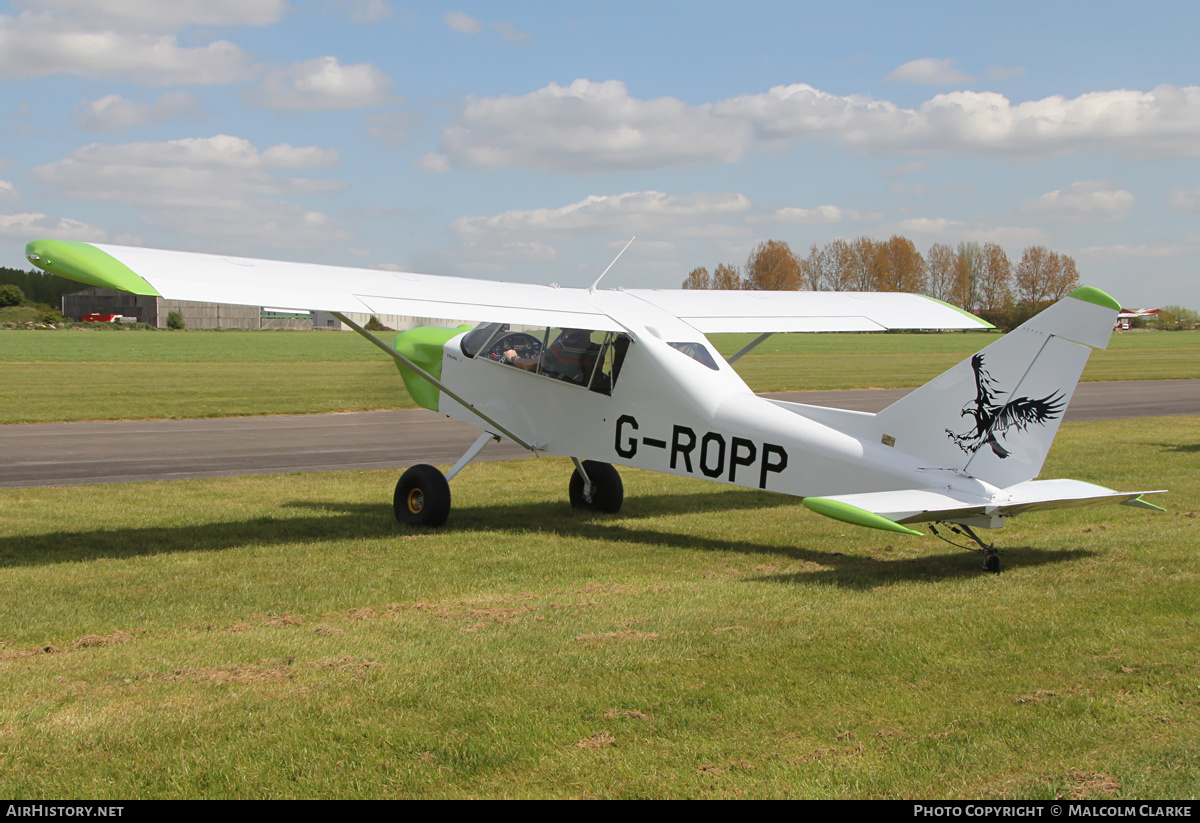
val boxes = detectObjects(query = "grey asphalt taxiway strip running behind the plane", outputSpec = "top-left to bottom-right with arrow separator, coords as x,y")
0,380 -> 1200,488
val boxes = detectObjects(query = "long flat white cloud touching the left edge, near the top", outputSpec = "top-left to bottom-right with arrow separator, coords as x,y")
0,13 -> 251,85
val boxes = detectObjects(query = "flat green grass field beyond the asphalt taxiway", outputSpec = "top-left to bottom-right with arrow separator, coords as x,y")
0,330 -> 1200,423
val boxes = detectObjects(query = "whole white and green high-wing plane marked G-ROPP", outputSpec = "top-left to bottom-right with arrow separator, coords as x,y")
25,240 -> 1160,571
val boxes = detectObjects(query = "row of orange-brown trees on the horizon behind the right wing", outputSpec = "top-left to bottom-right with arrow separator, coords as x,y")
683,235 -> 1079,326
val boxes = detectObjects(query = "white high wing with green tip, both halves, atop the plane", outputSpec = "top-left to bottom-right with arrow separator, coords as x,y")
25,240 -> 990,334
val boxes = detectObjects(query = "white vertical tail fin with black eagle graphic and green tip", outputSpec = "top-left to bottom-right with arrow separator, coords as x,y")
876,288 -> 1120,487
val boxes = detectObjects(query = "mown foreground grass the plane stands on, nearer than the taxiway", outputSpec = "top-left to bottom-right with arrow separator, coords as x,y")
0,417 -> 1200,798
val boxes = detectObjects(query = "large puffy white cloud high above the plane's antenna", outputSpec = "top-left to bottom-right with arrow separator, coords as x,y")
438,80 -> 751,172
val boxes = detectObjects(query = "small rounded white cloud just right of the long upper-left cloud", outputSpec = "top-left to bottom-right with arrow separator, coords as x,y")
246,56 -> 397,112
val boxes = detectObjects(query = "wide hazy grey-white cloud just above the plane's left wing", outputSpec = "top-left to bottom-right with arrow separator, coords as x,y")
29,134 -> 349,247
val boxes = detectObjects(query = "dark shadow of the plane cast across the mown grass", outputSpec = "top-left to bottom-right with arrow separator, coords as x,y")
0,491 -> 1094,589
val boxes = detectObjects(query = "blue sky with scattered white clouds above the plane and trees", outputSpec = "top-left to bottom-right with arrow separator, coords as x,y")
0,0 -> 1200,307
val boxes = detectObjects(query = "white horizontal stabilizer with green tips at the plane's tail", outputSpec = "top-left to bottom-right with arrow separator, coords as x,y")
804,480 -> 1162,534
